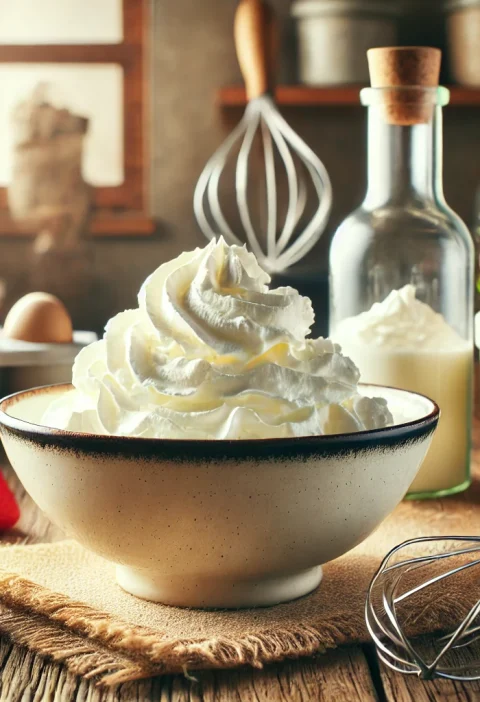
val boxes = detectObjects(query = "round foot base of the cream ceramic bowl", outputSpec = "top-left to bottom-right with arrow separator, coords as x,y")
116,566 -> 322,609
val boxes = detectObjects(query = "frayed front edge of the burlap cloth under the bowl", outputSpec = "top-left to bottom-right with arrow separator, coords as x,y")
0,571 -> 348,685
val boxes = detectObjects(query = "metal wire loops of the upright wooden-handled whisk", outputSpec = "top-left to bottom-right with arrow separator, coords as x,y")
194,95 -> 332,272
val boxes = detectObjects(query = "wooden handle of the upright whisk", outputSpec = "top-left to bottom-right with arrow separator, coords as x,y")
234,0 -> 277,100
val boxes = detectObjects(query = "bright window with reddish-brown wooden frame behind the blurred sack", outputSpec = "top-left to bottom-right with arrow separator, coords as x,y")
0,0 -> 154,235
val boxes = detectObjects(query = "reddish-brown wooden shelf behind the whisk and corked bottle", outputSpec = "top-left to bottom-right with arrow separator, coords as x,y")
217,85 -> 480,107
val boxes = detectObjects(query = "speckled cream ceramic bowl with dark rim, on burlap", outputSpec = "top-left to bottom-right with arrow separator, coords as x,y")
0,385 -> 439,607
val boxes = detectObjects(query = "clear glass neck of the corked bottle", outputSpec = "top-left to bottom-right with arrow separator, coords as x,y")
364,104 -> 444,209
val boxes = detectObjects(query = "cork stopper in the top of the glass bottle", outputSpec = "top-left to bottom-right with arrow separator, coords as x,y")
367,46 -> 442,125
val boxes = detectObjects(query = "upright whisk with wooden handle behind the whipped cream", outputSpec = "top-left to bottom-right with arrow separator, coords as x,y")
194,0 -> 332,273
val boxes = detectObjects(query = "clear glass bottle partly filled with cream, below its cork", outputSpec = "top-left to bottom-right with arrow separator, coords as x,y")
329,87 -> 474,498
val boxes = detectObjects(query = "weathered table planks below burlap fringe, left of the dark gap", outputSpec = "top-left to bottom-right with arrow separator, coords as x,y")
0,640 -> 378,702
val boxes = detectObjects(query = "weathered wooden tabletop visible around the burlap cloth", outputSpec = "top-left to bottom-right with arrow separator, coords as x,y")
0,421 -> 480,702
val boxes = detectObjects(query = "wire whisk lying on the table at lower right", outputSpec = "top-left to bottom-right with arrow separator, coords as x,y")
365,536 -> 480,680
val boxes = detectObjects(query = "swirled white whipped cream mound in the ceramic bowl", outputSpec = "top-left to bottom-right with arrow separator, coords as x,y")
43,239 -> 393,439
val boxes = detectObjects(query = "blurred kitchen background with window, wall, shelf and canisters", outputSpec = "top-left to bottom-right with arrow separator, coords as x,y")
0,0 -> 480,333
